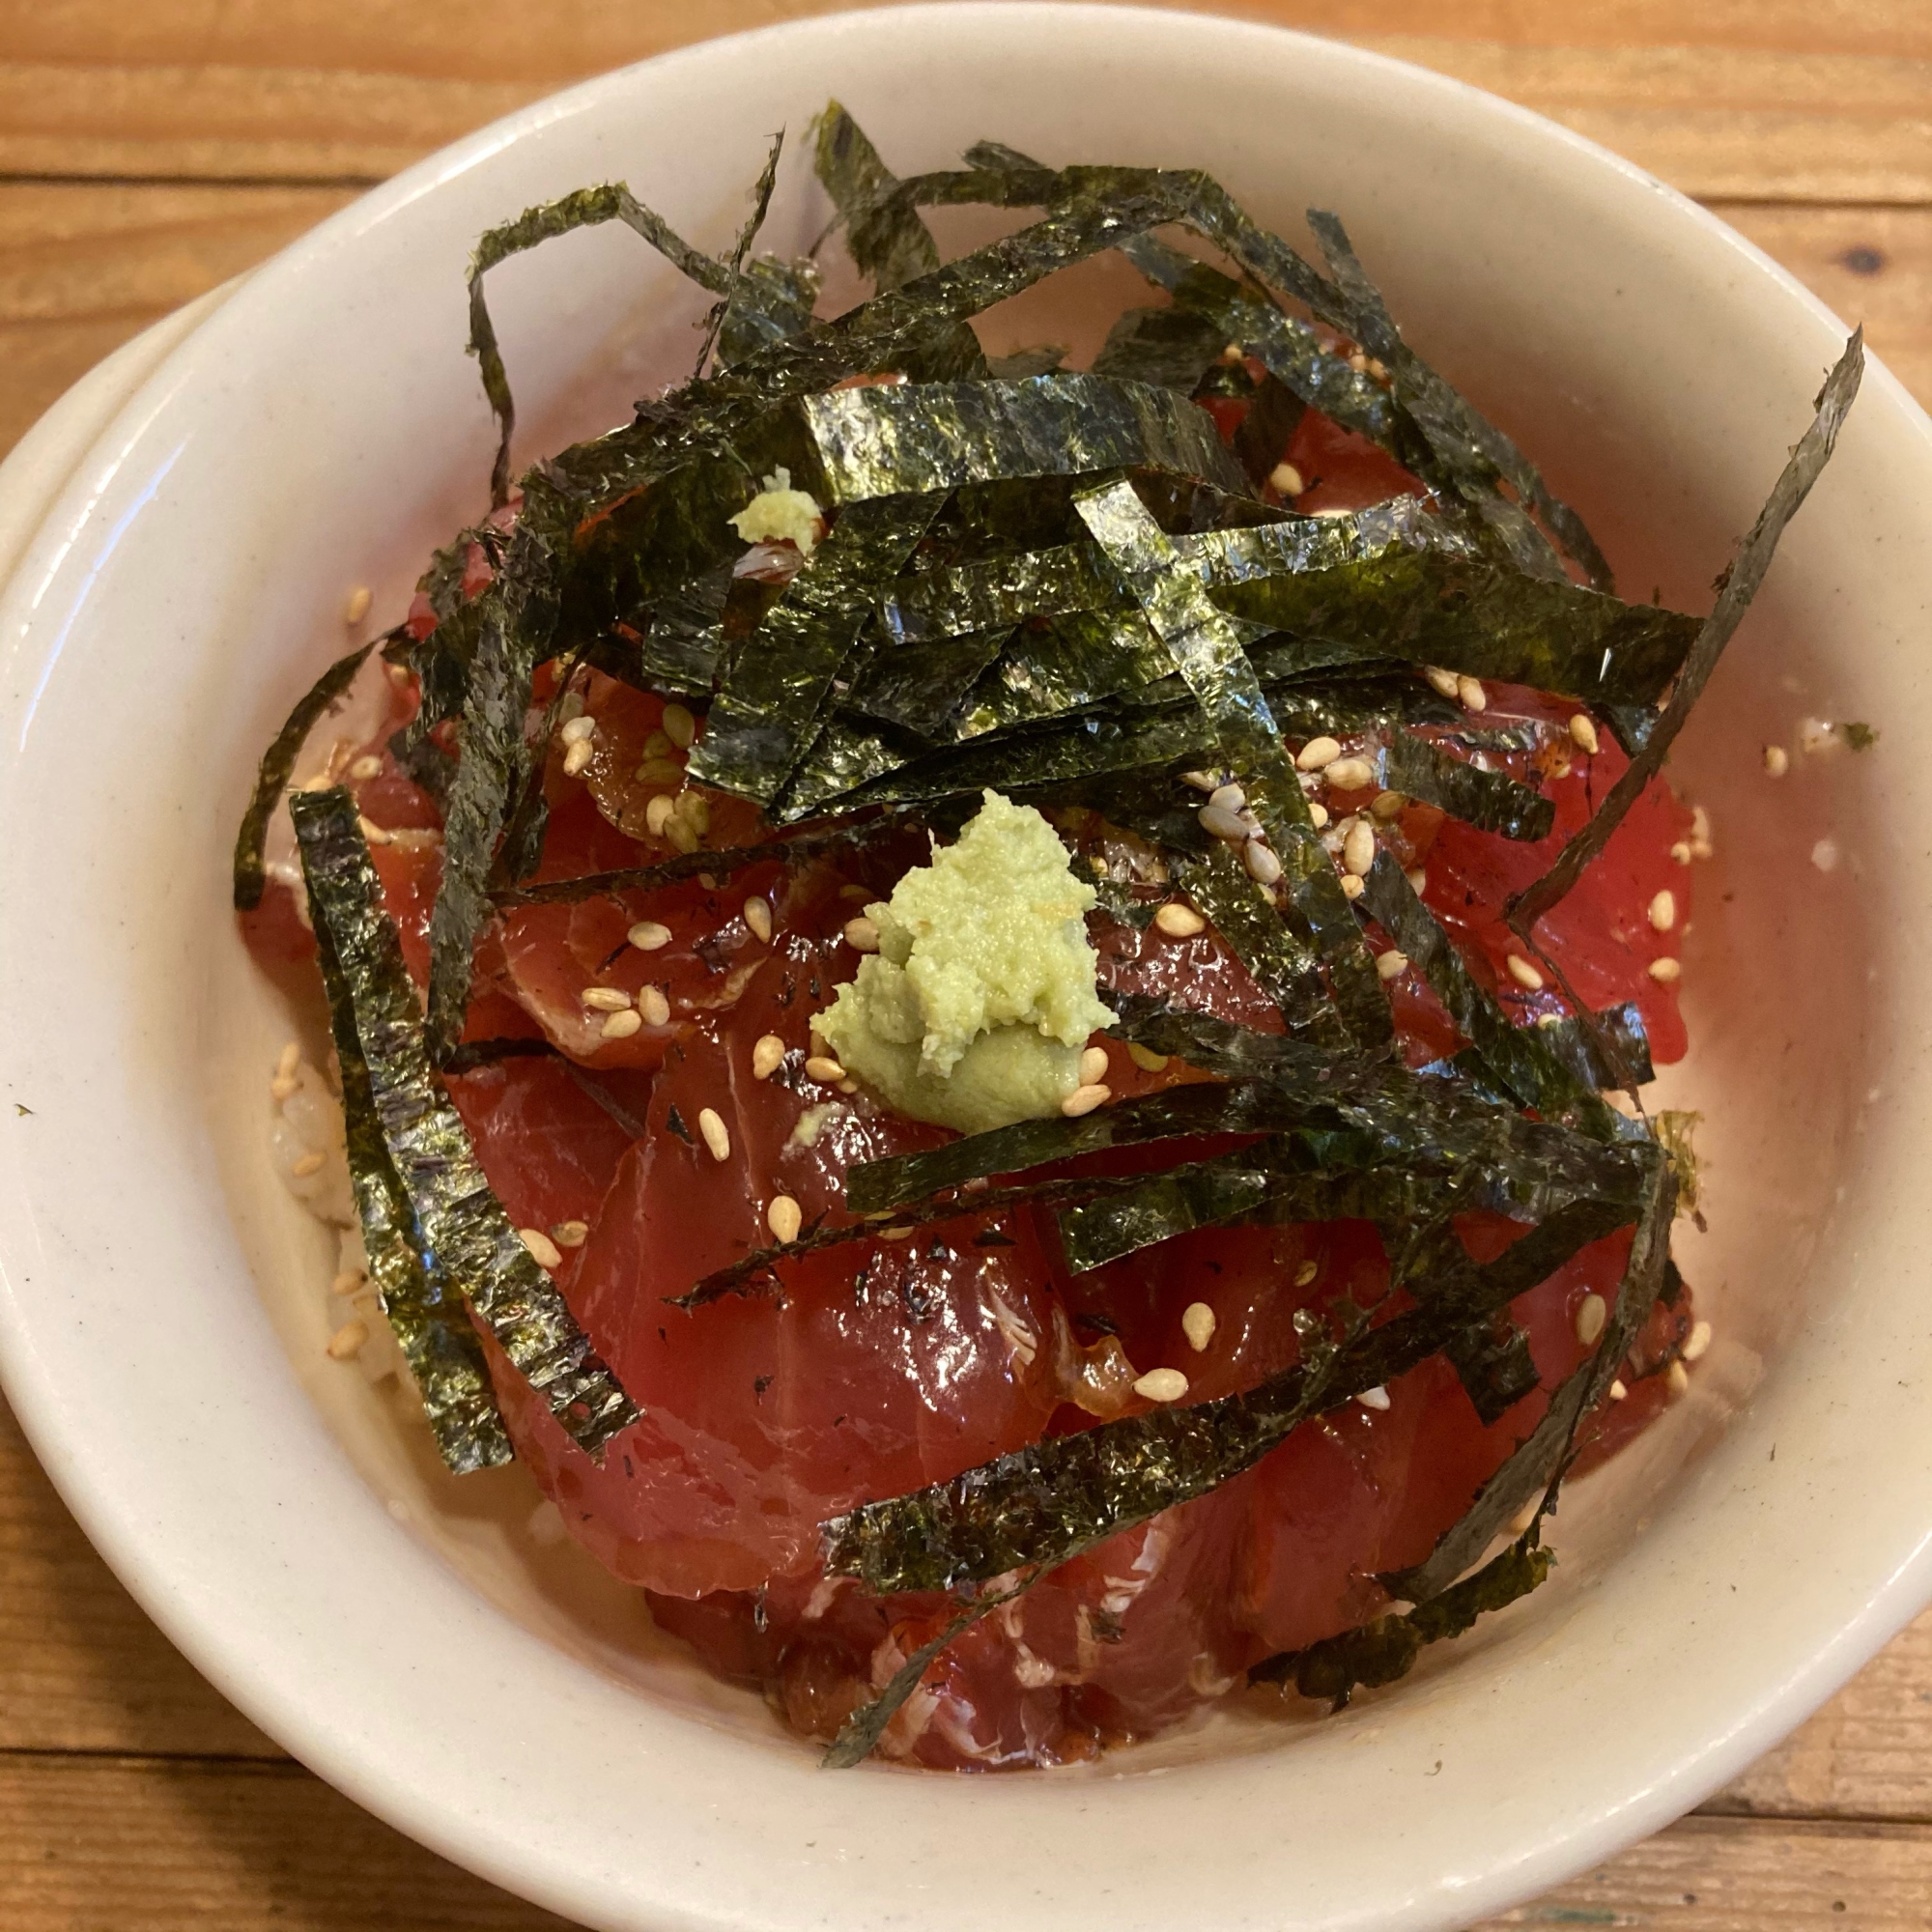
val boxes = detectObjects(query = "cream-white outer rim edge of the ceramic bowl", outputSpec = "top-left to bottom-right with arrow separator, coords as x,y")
0,0 -> 1932,1926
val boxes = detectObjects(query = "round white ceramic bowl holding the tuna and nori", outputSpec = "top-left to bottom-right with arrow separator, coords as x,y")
0,6 -> 1932,1932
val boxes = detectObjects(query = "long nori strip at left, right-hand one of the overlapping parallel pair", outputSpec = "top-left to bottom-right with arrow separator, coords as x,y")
290,788 -> 638,1455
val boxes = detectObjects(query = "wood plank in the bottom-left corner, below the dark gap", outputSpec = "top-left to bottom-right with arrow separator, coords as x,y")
0,1756 -> 568,1932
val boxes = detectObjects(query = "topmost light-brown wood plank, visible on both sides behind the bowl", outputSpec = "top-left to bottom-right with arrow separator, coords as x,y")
0,0 -> 1932,203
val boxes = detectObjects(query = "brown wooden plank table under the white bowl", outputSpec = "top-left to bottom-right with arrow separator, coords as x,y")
0,0 -> 1932,1932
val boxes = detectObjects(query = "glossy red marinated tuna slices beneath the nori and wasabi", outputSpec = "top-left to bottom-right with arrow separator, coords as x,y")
243,408 -> 1690,1768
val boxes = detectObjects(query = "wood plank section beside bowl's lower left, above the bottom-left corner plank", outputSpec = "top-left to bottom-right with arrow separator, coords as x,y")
0,1403 -> 284,1762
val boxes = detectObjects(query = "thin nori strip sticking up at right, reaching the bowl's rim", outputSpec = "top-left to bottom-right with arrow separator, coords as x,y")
1509,328 -> 1864,939
